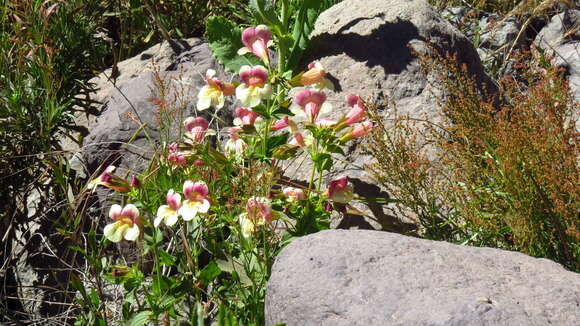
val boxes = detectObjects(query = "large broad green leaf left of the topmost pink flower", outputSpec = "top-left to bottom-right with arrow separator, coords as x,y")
205,16 -> 260,73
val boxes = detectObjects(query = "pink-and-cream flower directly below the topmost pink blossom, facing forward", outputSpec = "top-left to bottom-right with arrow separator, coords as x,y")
236,66 -> 272,108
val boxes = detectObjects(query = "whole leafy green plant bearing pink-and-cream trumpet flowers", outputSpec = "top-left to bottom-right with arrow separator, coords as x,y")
78,1 -> 372,324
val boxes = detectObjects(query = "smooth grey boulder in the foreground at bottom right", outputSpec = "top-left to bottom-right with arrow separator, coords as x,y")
266,230 -> 580,326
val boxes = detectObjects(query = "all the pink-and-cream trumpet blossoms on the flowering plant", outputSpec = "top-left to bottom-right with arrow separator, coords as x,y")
97,25 -> 373,242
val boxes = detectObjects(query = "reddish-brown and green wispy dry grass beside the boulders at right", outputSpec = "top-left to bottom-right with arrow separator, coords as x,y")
369,45 -> 580,270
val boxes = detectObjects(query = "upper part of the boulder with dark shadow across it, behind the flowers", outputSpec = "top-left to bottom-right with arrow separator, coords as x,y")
306,0 -> 491,125
